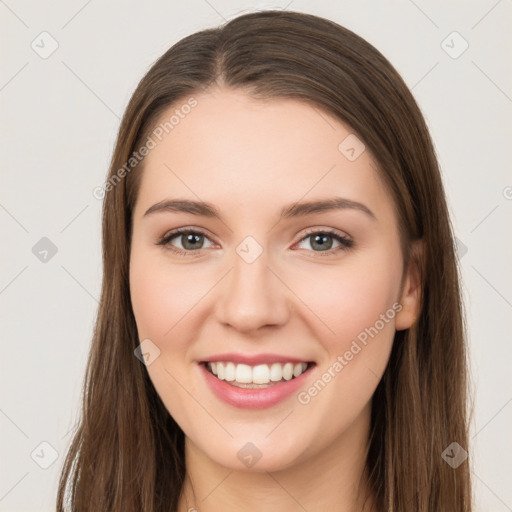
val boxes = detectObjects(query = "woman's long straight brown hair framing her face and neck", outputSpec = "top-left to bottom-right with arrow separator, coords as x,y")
57,11 -> 471,512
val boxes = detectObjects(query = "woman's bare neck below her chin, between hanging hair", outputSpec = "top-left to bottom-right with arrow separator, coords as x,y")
178,407 -> 375,512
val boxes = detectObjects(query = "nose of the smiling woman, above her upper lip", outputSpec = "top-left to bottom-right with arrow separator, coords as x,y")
216,252 -> 291,333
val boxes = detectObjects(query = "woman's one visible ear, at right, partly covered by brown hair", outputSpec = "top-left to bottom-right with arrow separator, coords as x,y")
395,240 -> 424,331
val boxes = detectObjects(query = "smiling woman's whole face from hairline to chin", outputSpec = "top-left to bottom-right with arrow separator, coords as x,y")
130,89 -> 415,471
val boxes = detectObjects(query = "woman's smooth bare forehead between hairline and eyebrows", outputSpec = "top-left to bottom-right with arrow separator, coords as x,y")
136,89 -> 391,222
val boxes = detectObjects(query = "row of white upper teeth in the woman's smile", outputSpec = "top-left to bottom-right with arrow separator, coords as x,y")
208,362 -> 308,384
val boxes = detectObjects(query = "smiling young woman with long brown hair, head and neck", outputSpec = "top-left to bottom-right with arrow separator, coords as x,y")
57,11 -> 471,512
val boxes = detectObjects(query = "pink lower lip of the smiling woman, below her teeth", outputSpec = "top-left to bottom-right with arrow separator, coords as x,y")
199,363 -> 315,409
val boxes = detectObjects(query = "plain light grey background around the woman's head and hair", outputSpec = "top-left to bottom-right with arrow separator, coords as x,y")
0,0 -> 512,512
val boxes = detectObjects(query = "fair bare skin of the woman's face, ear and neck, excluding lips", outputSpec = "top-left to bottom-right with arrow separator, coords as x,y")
130,88 -> 419,512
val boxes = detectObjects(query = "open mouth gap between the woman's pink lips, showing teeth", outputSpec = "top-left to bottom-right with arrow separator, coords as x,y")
202,361 -> 315,389
